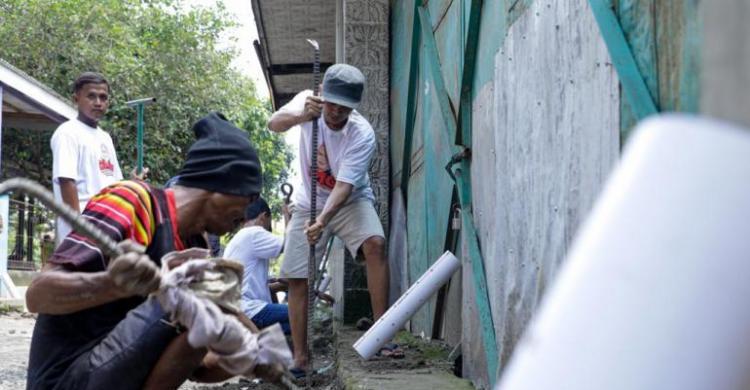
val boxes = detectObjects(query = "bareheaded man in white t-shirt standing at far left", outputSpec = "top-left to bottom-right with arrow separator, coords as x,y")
50,72 -> 147,245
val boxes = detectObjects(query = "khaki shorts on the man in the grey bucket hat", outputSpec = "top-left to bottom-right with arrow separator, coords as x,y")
279,200 -> 385,279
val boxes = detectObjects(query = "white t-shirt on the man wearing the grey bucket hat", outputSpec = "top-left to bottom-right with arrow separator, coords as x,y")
279,90 -> 375,210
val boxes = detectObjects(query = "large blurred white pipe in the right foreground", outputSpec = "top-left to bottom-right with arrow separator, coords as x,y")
498,115 -> 750,390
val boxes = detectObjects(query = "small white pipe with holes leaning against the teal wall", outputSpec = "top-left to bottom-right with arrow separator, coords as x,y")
354,251 -> 461,359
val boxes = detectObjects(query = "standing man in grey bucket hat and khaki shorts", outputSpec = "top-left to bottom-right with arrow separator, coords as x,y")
268,64 -> 388,374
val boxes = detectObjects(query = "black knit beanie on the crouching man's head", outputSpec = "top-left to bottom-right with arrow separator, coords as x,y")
177,112 -> 263,197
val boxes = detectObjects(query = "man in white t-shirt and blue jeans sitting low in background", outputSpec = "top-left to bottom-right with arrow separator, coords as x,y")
223,198 -> 290,334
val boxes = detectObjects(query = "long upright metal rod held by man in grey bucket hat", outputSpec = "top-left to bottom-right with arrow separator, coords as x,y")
305,39 -> 320,389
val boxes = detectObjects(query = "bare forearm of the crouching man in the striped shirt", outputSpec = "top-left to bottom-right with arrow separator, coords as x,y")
26,263 -> 124,314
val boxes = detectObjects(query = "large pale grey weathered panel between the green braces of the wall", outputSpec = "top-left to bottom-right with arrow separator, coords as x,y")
490,0 -> 620,374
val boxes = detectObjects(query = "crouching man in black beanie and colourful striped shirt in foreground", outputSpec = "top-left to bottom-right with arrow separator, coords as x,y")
26,113 -> 288,390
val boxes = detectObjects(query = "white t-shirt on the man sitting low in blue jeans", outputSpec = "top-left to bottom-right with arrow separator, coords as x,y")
224,226 -> 284,319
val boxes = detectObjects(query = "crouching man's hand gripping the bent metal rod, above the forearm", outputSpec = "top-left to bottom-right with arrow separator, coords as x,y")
107,240 -> 161,297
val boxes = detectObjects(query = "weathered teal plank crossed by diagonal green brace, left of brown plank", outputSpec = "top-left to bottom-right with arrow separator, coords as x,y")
616,0 -> 659,145
